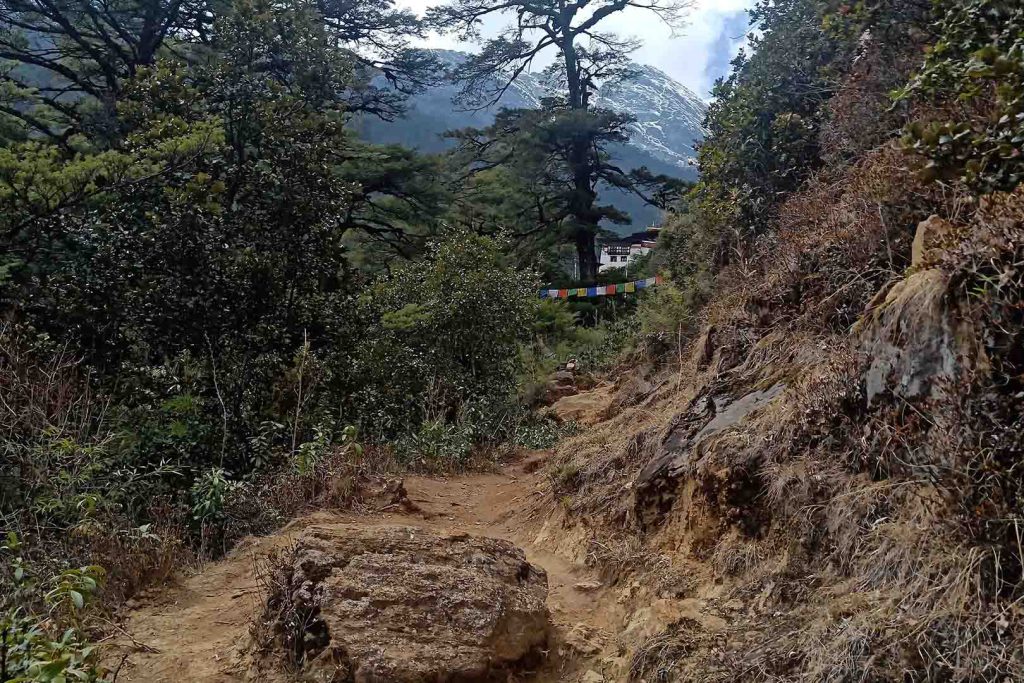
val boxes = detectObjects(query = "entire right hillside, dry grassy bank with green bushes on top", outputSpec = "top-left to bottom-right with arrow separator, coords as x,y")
553,0 -> 1024,681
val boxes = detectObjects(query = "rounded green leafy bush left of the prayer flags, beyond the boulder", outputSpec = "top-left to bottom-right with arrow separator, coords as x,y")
355,231 -> 538,442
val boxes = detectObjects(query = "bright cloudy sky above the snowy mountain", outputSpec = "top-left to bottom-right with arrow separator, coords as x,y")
397,0 -> 753,98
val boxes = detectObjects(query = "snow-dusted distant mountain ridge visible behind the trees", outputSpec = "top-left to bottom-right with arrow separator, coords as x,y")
358,50 -> 708,232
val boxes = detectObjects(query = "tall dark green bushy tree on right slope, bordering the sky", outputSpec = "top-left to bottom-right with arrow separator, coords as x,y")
694,0 -> 849,245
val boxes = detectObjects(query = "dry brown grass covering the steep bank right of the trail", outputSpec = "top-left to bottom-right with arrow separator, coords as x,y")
556,132 -> 1024,682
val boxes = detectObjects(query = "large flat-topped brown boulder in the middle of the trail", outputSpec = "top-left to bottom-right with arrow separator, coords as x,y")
267,525 -> 548,683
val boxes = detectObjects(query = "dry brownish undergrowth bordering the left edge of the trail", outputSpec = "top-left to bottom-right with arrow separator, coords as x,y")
0,324 -> 409,624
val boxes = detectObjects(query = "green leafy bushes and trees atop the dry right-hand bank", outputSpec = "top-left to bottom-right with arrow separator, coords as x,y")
659,0 -> 1022,321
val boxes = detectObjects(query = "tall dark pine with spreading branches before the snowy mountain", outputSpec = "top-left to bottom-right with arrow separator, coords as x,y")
428,0 -> 692,282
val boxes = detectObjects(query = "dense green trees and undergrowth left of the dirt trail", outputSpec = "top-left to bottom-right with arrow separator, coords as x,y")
0,0 -> 677,681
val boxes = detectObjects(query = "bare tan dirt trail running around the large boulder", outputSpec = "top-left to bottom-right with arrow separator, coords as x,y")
114,460 -> 615,683
